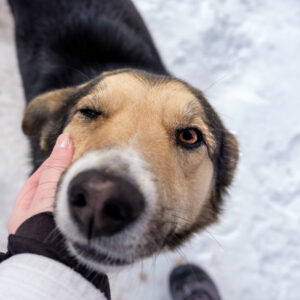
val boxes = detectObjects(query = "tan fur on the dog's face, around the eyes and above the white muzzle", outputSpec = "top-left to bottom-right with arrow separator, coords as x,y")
64,73 -> 215,232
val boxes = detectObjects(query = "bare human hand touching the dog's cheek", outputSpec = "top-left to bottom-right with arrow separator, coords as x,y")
7,134 -> 74,234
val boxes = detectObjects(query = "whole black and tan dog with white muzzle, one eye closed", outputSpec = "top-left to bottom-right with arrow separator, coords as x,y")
9,0 -> 238,271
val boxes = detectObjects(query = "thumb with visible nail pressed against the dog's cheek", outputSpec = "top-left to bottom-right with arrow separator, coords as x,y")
32,134 -> 74,212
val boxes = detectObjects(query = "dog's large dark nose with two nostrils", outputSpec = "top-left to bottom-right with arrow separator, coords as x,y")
68,170 -> 145,238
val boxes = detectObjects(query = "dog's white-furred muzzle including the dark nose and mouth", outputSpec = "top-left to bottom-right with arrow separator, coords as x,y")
55,147 -> 157,268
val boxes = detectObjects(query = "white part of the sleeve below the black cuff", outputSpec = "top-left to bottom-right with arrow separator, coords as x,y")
0,254 -> 106,300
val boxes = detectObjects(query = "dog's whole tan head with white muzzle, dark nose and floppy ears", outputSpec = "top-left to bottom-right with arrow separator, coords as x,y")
23,70 -> 238,269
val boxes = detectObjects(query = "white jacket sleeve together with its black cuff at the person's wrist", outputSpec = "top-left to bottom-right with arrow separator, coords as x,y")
0,213 -> 110,299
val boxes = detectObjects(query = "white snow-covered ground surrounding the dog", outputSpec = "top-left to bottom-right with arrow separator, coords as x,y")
0,0 -> 300,300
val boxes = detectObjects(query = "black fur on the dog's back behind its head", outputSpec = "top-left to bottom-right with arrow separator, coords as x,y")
9,0 -> 168,102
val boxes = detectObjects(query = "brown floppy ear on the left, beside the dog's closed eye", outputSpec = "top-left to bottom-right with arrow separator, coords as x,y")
22,88 -> 75,136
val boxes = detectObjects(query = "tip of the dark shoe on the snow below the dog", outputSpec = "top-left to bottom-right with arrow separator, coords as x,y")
170,264 -> 221,300
